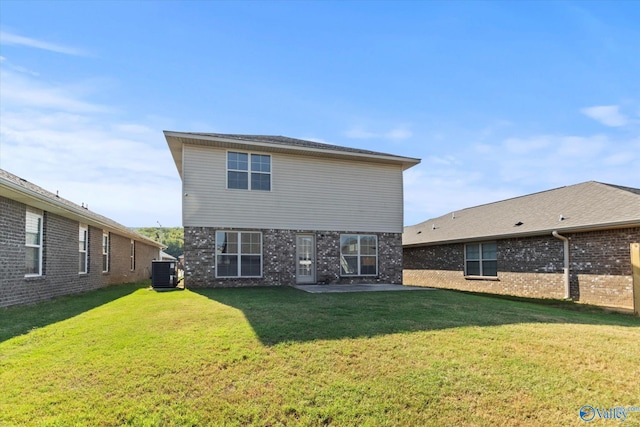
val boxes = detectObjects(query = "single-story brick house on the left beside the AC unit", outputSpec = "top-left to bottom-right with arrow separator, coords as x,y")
0,169 -> 164,307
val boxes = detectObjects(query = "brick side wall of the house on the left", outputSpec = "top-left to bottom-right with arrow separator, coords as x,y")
0,197 -> 159,307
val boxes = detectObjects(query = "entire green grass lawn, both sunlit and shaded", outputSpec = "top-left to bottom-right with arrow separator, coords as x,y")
0,283 -> 640,427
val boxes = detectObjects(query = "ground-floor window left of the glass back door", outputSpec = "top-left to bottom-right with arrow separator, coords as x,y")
216,231 -> 262,277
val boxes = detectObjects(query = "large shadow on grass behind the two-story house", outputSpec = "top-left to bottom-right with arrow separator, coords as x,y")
191,287 -> 640,345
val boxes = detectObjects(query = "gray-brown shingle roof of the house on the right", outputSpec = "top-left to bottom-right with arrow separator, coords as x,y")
402,181 -> 640,246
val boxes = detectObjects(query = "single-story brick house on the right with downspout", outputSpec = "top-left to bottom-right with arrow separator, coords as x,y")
403,181 -> 640,311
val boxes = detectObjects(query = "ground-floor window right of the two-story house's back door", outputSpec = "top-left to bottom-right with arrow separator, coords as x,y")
340,234 -> 378,276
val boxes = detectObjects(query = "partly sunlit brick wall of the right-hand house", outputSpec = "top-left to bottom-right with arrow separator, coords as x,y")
403,228 -> 640,310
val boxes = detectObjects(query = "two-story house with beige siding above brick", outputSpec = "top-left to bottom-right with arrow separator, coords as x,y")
165,131 -> 420,287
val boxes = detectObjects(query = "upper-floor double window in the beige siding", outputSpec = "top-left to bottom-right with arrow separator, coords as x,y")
227,151 -> 271,191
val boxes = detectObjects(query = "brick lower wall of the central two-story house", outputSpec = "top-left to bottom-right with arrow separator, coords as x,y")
184,227 -> 402,288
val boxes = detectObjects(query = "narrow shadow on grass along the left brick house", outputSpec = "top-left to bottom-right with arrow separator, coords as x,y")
0,281 -> 151,342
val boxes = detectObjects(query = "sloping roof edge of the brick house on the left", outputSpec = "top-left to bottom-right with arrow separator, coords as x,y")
0,169 -> 164,247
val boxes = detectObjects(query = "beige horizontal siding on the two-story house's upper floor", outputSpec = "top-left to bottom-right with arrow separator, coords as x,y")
183,145 -> 403,233
